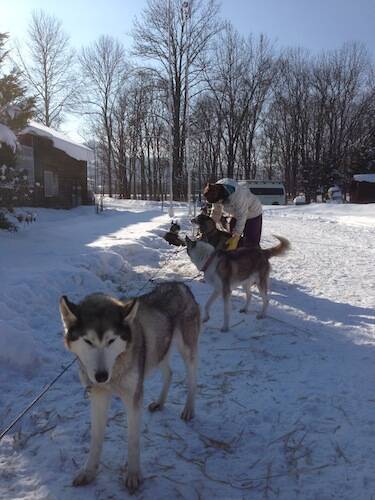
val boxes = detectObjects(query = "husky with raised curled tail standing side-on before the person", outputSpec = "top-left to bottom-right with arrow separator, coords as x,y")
186,236 -> 290,332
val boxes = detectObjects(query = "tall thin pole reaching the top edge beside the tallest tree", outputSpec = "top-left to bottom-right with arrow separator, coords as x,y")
181,1 -> 192,216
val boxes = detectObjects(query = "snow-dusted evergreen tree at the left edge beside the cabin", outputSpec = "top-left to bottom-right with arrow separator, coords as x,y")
0,33 -> 34,230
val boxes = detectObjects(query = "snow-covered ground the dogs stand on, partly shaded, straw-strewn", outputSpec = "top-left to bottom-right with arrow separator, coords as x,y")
0,200 -> 375,500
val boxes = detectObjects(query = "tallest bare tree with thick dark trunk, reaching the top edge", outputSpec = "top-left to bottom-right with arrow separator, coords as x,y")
133,0 -> 220,199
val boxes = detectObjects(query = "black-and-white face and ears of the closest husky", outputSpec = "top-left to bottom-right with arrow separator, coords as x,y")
60,294 -> 137,384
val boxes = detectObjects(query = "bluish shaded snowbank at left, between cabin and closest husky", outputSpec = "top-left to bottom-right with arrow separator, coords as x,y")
0,205 -> 169,371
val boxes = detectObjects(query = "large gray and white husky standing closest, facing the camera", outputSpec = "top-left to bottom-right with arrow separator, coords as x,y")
60,282 -> 200,492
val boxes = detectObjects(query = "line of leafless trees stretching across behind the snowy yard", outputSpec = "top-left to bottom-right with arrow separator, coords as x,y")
8,0 -> 375,199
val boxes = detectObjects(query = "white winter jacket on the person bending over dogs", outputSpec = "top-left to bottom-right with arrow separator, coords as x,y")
211,178 -> 263,235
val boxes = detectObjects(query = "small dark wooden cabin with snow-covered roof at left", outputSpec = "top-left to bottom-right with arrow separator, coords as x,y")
17,121 -> 92,208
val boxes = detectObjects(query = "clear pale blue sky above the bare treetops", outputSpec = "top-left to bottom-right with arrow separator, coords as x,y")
0,0 -> 375,54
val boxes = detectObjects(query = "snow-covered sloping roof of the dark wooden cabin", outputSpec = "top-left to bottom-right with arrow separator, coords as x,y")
21,120 -> 93,161
